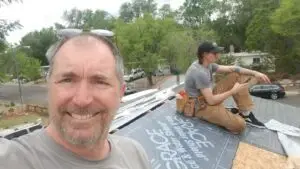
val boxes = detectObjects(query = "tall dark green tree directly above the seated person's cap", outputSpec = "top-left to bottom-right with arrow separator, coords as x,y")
209,0 -> 257,52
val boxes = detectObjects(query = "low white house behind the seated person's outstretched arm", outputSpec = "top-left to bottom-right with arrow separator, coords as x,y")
225,51 -> 275,72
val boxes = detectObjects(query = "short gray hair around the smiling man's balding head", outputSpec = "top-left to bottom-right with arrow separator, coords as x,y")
46,33 -> 124,84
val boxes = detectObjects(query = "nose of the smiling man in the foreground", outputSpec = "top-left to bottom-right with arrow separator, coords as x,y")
73,82 -> 93,107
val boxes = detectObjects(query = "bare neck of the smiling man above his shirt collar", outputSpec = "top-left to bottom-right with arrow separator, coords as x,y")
46,125 -> 110,161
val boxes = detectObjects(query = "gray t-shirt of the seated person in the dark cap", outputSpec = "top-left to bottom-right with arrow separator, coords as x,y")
184,61 -> 218,97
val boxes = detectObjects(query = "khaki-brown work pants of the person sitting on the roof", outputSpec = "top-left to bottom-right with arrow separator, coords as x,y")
195,73 -> 257,134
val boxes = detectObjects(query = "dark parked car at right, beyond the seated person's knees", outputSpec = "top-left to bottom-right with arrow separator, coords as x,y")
249,83 -> 285,100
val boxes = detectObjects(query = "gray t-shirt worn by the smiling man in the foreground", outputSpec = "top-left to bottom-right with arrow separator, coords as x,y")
0,130 -> 150,169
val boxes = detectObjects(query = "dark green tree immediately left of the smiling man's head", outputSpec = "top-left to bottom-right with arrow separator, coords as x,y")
21,27 -> 57,65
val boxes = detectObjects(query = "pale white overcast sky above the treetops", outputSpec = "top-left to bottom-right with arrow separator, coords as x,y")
0,0 -> 184,43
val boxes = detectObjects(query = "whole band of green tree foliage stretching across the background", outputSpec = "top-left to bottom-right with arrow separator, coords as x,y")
0,0 -> 300,84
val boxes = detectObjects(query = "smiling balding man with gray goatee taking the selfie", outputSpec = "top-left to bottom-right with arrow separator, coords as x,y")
0,33 -> 150,169
